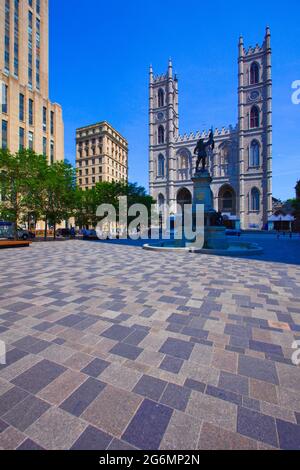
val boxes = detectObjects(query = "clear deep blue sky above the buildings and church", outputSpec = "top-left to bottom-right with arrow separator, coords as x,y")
49,0 -> 300,200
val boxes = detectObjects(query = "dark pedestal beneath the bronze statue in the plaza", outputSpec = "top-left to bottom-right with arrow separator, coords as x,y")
192,170 -> 229,249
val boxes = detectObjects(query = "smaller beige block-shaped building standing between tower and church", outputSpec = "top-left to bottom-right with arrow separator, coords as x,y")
76,121 -> 128,189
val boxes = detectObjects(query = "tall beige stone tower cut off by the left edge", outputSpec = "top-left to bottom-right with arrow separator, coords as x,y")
0,0 -> 64,163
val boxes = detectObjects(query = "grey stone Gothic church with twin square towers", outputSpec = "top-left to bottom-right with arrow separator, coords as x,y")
149,28 -> 272,229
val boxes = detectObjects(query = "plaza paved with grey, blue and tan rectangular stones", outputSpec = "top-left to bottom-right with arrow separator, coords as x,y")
0,240 -> 300,450
